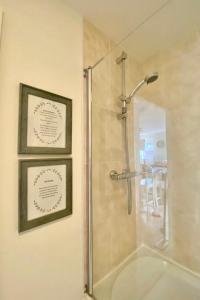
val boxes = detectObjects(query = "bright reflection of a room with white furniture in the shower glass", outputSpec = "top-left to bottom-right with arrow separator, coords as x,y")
134,98 -> 169,249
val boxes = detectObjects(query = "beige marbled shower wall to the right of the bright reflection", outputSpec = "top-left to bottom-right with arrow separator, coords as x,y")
143,34 -> 200,272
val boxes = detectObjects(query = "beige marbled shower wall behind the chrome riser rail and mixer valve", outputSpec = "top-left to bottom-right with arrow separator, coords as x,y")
84,22 -> 139,282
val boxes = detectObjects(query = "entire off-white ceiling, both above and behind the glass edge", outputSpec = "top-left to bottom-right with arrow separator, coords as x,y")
67,0 -> 200,62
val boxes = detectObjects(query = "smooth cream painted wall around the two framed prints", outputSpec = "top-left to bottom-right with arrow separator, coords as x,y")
0,0 -> 83,300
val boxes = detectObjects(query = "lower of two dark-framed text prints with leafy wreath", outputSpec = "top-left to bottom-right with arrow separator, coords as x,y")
19,158 -> 72,232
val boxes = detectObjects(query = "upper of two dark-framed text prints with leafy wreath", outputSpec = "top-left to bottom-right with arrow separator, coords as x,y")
18,83 -> 72,154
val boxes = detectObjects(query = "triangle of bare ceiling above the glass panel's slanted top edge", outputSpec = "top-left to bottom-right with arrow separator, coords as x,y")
67,0 -> 169,42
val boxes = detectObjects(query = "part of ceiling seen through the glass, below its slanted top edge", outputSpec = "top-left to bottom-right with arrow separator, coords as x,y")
122,0 -> 200,63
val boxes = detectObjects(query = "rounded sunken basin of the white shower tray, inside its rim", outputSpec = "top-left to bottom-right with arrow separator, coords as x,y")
94,247 -> 200,300
